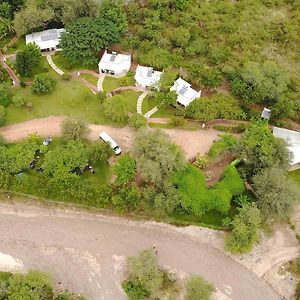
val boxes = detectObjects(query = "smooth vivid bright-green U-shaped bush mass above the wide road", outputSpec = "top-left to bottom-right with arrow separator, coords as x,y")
174,166 -> 245,216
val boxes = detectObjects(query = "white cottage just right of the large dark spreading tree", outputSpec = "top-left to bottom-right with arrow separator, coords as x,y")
98,50 -> 131,76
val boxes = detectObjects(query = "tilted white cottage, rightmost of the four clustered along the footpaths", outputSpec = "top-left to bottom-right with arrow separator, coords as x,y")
170,77 -> 201,107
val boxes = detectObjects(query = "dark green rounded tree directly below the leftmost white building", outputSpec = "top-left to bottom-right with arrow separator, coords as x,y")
15,44 -> 42,77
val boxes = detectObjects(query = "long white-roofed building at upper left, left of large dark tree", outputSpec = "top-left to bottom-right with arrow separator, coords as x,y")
25,28 -> 65,50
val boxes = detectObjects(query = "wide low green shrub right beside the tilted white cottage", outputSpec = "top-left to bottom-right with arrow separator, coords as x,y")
186,94 -> 242,121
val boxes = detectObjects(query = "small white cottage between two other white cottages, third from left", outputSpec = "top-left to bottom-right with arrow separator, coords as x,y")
134,65 -> 163,88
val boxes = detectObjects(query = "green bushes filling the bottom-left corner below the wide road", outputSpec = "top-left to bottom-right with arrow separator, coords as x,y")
0,271 -> 85,300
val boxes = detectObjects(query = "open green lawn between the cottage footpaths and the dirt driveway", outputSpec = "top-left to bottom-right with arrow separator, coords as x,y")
7,80 -> 119,126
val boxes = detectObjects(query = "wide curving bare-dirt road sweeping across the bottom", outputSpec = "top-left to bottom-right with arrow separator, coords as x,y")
0,203 -> 280,300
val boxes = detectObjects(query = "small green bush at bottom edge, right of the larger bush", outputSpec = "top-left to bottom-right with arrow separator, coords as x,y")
184,275 -> 214,300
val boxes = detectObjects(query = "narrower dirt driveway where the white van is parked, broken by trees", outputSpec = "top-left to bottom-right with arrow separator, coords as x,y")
0,116 -> 220,158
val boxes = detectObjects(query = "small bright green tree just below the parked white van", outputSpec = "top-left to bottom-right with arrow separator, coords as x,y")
114,154 -> 136,185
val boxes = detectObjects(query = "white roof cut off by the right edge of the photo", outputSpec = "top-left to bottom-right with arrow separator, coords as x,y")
273,127 -> 300,166
